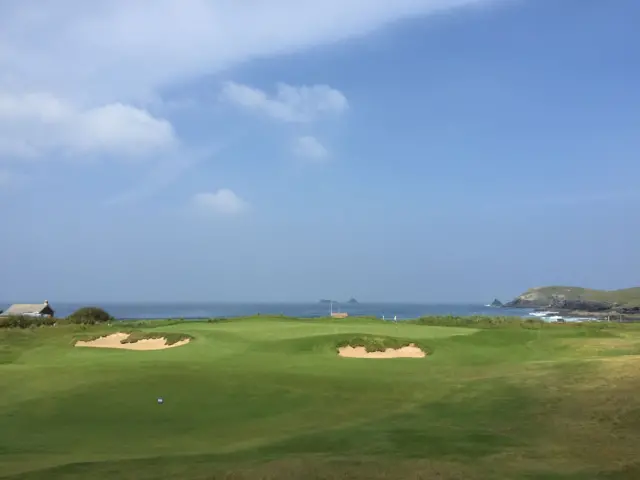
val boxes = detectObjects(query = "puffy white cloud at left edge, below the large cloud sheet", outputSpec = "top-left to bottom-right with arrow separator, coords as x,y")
0,92 -> 176,157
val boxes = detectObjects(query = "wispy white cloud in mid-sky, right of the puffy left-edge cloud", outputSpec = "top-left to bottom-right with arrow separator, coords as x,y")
222,82 -> 349,122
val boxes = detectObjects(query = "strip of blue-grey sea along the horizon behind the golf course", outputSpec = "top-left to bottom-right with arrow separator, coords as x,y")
0,301 -> 531,320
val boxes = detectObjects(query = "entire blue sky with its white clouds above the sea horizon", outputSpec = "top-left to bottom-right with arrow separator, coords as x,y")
0,0 -> 640,302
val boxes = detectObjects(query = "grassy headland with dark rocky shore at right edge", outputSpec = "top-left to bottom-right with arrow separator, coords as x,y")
504,286 -> 640,318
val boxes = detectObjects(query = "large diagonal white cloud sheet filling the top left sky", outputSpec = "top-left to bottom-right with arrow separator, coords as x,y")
0,0 -> 493,106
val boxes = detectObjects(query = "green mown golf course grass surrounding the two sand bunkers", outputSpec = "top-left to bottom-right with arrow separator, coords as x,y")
0,317 -> 640,480
